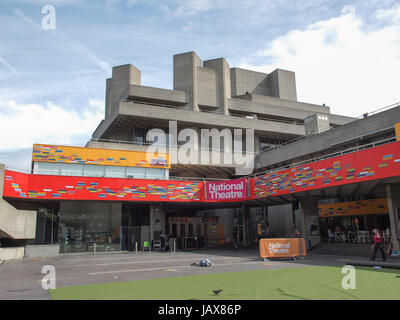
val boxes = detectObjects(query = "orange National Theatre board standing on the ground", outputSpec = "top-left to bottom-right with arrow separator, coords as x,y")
259,238 -> 306,259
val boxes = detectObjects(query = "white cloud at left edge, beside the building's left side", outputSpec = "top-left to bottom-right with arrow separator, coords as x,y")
0,99 -> 104,152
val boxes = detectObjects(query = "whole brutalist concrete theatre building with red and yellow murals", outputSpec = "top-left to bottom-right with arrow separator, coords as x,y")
0,52 -> 400,256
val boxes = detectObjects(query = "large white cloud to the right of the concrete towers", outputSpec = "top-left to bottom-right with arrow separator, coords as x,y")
241,5 -> 400,116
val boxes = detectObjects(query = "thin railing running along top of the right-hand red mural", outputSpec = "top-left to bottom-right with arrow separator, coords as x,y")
244,136 -> 400,178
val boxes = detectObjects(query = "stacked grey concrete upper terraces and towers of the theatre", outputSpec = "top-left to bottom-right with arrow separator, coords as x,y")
87,52 -> 353,178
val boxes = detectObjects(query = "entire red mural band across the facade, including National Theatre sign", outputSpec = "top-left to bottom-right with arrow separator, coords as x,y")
4,141 -> 400,202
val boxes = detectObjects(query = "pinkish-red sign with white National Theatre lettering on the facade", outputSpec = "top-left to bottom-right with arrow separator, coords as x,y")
206,179 -> 247,201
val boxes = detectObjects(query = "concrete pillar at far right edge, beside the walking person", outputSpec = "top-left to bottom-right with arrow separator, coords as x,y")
386,184 -> 400,252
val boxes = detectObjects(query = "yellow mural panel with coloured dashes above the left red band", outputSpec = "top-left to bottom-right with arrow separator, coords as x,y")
32,144 -> 170,168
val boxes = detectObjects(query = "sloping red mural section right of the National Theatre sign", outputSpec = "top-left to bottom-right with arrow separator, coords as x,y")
250,142 -> 400,199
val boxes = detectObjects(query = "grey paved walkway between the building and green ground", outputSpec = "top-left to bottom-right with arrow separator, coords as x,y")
0,250 -> 400,299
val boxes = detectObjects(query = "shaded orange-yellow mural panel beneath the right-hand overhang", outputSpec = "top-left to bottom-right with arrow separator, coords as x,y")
318,198 -> 388,218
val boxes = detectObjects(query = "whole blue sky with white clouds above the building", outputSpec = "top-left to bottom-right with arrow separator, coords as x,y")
0,0 -> 400,168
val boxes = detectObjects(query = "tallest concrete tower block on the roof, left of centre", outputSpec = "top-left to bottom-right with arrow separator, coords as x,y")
174,52 -> 201,111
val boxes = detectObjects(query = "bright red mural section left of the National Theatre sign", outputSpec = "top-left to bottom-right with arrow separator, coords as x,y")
4,170 -> 204,201
